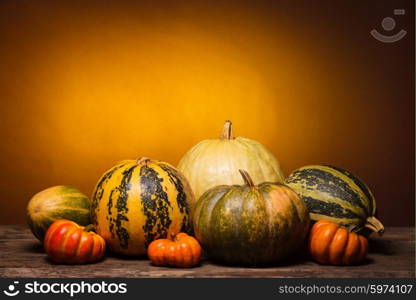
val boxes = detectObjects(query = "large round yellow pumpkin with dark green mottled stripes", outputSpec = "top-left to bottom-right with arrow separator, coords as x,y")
91,158 -> 194,255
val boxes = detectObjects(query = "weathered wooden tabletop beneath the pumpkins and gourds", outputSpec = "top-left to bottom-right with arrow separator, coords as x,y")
0,225 -> 415,278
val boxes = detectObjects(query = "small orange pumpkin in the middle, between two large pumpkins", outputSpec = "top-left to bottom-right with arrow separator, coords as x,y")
147,232 -> 201,268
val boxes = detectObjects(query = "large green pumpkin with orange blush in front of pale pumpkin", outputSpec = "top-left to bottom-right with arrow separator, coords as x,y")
193,170 -> 309,266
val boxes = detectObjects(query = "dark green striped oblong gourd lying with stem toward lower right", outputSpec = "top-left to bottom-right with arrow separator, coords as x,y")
286,165 -> 384,235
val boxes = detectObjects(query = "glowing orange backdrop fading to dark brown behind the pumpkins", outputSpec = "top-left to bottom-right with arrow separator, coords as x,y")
0,0 -> 414,225
